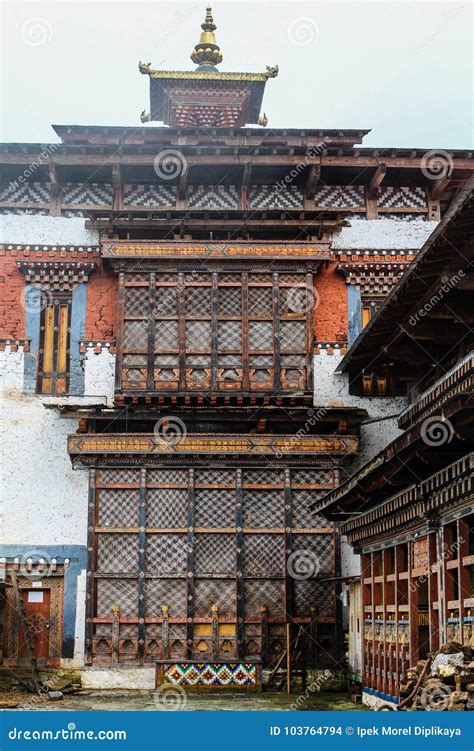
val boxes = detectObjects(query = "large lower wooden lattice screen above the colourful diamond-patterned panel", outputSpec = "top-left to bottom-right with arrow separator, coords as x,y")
87,466 -> 336,663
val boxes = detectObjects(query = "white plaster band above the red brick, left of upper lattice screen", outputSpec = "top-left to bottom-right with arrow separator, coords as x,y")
0,214 -> 99,246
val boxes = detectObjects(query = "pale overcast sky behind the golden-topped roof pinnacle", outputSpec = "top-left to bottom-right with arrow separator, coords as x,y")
0,0 -> 473,148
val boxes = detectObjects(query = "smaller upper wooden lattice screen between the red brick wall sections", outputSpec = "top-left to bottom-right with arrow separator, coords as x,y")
116,270 -> 314,400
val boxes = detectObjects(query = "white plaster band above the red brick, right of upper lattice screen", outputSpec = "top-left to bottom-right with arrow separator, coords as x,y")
332,219 -> 437,250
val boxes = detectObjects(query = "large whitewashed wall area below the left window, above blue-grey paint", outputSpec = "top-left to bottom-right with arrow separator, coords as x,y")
0,347 -> 87,547
